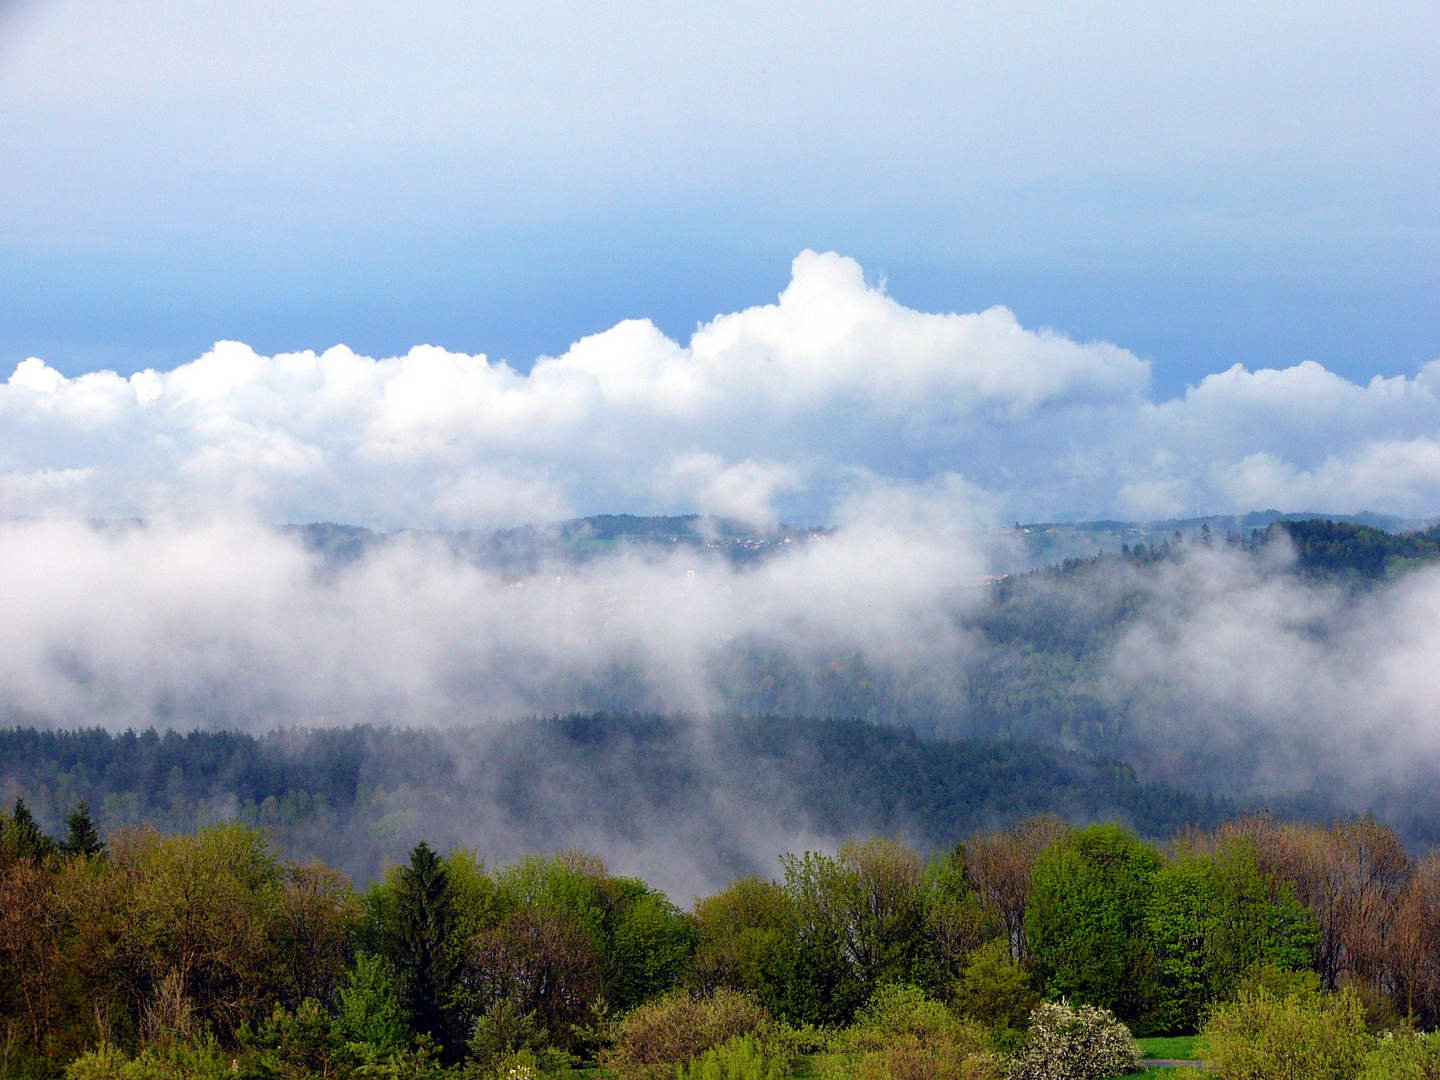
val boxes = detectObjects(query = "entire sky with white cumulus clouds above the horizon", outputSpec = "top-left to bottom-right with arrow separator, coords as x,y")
0,0 -> 1440,527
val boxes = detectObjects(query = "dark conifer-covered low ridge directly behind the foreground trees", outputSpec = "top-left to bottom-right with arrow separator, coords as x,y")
0,714 -> 1234,880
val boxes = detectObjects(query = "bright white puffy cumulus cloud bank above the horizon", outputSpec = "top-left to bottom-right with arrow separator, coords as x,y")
11,251 -> 1440,527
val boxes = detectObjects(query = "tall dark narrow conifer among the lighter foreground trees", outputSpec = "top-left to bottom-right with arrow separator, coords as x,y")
389,841 -> 455,1047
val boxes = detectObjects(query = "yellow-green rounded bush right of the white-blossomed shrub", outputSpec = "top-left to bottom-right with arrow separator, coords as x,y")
1198,982 -> 1371,1080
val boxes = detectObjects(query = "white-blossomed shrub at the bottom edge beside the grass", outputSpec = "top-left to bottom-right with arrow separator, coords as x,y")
1009,1001 -> 1140,1080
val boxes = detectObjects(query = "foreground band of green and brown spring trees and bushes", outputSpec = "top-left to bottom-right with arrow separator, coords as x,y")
0,801 -> 1440,1080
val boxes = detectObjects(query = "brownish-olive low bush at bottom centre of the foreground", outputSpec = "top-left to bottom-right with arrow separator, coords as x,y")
600,988 -> 770,1077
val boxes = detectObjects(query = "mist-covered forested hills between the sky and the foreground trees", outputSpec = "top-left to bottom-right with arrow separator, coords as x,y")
0,512 -> 1440,896
